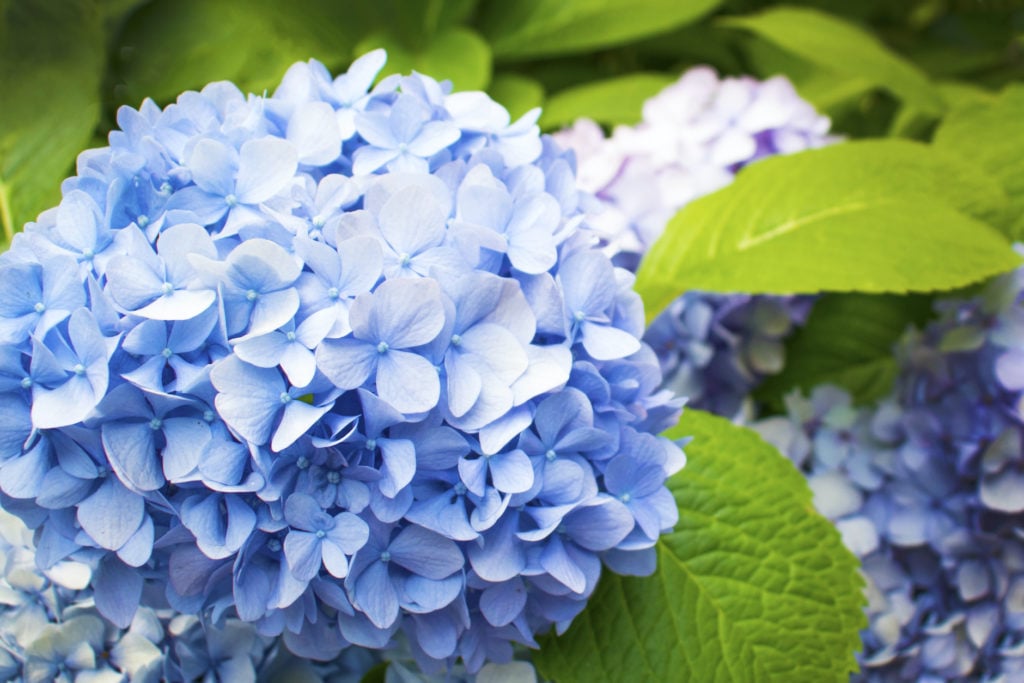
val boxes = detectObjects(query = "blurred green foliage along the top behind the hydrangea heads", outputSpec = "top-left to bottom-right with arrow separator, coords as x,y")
0,0 -> 1024,241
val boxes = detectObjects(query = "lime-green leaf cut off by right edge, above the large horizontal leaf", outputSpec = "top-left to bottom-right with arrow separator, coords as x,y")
935,85 -> 1024,240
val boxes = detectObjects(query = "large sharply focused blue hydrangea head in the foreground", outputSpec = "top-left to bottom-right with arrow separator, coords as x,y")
0,51 -> 684,679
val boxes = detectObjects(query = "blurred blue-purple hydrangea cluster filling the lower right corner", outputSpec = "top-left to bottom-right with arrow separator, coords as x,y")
758,264 -> 1024,682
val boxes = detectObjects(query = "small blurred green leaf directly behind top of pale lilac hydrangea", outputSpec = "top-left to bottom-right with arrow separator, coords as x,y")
541,74 -> 676,130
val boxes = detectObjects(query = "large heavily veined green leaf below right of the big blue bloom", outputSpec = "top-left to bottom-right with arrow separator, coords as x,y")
534,410 -> 865,683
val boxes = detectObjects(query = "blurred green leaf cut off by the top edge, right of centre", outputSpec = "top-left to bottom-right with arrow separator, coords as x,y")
479,0 -> 722,60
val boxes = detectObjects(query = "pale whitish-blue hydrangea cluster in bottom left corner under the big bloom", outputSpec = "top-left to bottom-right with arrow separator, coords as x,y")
0,511 -> 323,683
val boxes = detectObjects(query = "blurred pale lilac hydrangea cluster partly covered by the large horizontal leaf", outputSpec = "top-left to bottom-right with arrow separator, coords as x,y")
556,67 -> 839,417
